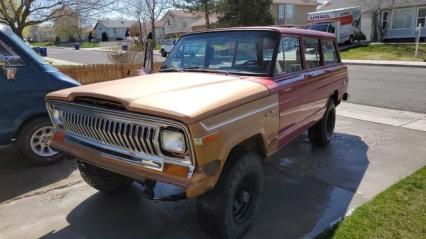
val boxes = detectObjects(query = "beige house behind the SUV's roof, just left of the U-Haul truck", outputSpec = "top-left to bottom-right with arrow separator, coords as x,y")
271,0 -> 317,26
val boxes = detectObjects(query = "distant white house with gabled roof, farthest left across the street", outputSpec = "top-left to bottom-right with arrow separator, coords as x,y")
94,20 -> 137,41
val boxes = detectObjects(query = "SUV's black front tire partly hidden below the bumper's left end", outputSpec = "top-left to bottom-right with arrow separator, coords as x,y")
78,162 -> 134,193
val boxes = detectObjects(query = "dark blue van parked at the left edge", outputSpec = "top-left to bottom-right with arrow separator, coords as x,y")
0,24 -> 79,165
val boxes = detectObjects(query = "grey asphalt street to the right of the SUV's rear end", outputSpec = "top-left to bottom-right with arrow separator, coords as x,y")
348,65 -> 426,113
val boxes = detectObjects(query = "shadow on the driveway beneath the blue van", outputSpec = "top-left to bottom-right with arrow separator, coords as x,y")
0,144 -> 76,203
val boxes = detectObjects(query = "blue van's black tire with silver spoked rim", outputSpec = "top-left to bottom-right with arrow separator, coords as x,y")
17,116 -> 65,166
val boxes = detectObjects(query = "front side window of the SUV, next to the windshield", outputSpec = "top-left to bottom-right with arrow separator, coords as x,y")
275,37 -> 302,73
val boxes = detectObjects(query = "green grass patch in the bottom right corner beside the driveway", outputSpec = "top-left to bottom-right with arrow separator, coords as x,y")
317,167 -> 426,239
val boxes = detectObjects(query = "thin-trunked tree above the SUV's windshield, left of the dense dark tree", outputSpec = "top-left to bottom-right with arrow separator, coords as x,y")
175,0 -> 218,28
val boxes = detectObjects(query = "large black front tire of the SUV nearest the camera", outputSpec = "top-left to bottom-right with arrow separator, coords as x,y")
196,151 -> 264,238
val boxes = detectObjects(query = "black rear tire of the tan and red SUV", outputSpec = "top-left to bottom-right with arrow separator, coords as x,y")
308,99 -> 336,146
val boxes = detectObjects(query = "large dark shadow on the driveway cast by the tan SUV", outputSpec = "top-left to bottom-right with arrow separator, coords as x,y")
38,134 -> 369,239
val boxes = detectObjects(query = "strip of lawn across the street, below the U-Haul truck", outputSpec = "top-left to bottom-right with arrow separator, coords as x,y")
341,44 -> 426,61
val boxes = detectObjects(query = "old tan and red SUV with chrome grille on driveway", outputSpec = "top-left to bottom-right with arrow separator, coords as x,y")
47,27 -> 348,238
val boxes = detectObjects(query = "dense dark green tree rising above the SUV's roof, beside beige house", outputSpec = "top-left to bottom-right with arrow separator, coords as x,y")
219,0 -> 274,26
